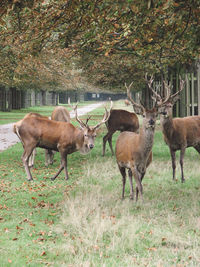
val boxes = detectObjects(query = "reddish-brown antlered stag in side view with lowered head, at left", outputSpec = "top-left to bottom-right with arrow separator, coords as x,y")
13,102 -> 112,181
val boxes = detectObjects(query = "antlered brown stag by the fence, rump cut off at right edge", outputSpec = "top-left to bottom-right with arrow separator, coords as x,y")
148,78 -> 200,183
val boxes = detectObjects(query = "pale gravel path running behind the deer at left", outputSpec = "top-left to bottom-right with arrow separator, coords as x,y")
0,102 -> 103,152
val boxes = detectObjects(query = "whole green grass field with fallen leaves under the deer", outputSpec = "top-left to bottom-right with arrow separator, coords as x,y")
0,101 -> 200,267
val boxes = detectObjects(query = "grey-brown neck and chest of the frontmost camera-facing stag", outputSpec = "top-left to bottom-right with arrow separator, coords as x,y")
140,126 -> 155,156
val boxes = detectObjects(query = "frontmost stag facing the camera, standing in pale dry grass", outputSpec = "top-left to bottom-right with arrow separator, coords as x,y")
115,80 -> 158,202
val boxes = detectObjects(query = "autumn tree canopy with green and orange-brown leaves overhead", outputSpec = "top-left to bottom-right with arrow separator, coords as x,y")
0,0 -> 200,90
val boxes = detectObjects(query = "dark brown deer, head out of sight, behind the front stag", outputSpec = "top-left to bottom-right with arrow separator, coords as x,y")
102,94 -> 139,156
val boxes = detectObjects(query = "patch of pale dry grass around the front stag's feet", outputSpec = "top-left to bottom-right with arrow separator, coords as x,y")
53,138 -> 200,266
